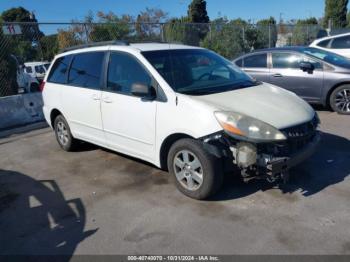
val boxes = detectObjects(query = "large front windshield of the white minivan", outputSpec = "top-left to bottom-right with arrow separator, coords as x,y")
142,49 -> 258,95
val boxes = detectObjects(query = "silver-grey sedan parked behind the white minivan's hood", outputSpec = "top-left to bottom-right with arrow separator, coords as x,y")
233,47 -> 350,114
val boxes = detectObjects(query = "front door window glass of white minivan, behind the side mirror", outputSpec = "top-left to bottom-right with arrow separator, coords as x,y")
107,52 -> 152,95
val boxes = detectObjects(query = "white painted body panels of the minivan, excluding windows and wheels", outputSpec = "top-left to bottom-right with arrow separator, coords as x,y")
43,43 -> 315,167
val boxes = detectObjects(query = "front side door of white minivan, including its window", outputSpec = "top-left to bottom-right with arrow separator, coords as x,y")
101,51 -> 157,161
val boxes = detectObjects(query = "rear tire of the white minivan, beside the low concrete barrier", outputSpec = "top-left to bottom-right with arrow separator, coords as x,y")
54,115 -> 78,152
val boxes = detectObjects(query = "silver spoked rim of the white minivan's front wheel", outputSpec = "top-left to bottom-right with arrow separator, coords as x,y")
174,150 -> 203,191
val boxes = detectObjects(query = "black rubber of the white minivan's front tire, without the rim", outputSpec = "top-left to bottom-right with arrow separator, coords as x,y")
168,138 -> 224,200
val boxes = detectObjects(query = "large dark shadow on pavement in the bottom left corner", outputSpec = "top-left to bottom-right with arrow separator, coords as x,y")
0,169 -> 97,261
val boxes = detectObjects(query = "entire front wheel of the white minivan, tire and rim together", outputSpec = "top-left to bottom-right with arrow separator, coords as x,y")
168,138 -> 223,199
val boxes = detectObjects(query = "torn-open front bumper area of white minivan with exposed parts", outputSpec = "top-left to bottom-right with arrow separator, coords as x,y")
203,121 -> 321,182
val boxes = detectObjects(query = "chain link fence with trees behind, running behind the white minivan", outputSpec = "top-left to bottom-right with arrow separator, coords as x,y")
0,22 -> 338,97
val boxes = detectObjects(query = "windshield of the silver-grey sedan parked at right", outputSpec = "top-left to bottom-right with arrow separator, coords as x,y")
303,47 -> 350,68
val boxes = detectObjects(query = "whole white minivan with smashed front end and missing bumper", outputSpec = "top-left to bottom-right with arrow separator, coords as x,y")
43,42 -> 320,199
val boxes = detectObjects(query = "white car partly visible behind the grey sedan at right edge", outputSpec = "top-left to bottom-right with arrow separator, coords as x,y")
310,33 -> 350,58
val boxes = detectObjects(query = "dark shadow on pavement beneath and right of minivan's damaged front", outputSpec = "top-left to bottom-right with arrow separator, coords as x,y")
210,133 -> 350,201
